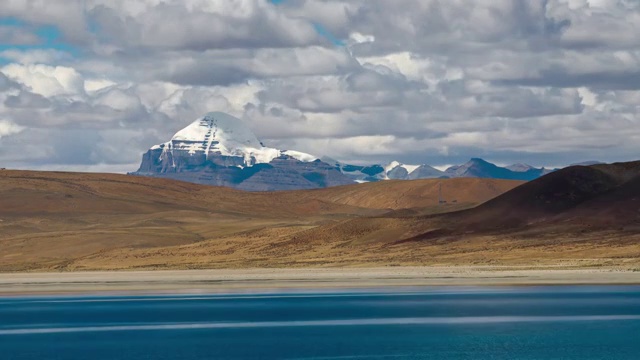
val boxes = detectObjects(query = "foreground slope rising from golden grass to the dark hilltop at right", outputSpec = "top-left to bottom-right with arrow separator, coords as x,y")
69,163 -> 640,269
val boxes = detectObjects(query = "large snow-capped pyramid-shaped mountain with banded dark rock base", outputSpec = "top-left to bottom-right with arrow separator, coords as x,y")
133,112 -> 353,191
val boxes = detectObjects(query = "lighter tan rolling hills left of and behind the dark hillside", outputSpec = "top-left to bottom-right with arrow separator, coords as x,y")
0,170 -> 520,270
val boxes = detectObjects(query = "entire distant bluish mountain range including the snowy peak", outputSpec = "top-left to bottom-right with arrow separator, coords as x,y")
131,112 -> 580,191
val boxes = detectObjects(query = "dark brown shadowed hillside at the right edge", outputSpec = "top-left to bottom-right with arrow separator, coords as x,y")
442,162 -> 640,232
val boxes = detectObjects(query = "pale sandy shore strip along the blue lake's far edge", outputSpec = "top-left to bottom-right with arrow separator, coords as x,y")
0,266 -> 640,296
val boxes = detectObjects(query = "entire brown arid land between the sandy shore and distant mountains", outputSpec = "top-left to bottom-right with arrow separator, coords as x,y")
0,163 -> 640,272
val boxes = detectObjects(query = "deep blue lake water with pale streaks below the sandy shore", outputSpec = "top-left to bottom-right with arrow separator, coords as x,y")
0,286 -> 640,360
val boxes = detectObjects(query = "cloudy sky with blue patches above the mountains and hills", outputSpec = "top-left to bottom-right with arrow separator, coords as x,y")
0,0 -> 640,172
